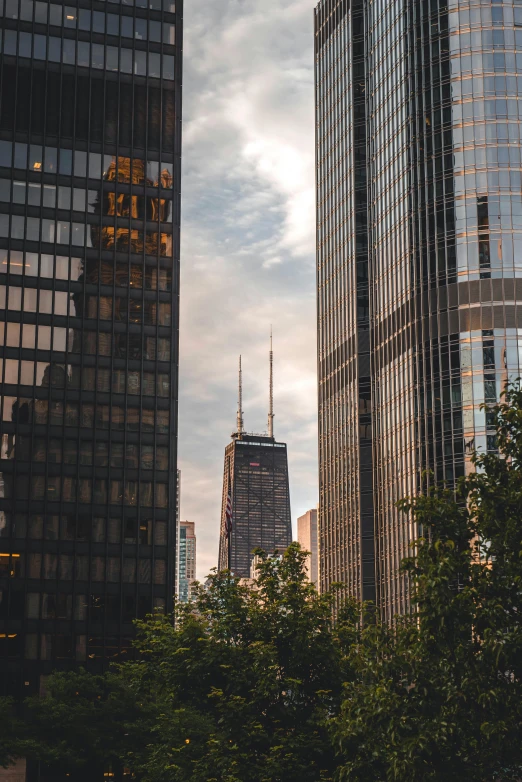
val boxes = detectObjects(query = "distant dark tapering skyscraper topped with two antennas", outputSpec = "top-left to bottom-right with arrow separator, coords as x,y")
219,345 -> 292,578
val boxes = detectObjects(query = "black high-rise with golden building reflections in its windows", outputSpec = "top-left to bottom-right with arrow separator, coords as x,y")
0,0 -> 182,724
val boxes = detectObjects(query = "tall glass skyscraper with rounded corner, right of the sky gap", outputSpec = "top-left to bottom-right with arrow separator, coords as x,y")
315,0 -> 522,619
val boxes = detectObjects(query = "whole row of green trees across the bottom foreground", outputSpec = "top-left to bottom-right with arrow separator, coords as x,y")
0,388 -> 522,782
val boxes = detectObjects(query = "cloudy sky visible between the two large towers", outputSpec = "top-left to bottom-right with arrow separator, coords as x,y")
179,0 -> 317,578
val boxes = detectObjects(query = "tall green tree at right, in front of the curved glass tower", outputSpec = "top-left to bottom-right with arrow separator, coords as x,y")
333,388 -> 522,782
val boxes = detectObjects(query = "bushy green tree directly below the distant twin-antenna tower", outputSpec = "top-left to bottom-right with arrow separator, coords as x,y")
124,545 -> 350,782
